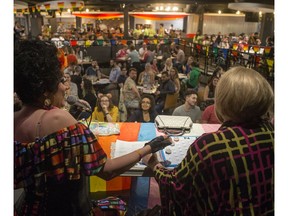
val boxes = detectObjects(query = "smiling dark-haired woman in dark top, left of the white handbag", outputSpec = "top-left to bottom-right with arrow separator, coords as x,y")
127,94 -> 157,122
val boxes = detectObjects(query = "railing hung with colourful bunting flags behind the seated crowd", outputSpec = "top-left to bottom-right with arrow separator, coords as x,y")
63,38 -> 274,82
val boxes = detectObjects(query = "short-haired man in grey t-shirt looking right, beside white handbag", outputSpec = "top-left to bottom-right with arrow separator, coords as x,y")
172,89 -> 201,123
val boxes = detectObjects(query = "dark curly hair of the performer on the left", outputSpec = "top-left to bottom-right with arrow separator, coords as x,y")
14,40 -> 63,104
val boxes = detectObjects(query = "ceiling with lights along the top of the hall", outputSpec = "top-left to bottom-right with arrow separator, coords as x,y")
18,0 -> 274,14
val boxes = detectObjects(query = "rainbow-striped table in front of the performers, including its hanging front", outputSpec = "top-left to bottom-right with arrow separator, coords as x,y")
89,122 -> 220,215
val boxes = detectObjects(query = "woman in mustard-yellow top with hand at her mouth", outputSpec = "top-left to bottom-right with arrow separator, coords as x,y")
92,94 -> 119,122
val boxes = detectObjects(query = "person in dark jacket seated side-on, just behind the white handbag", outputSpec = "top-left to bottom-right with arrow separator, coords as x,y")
155,71 -> 175,114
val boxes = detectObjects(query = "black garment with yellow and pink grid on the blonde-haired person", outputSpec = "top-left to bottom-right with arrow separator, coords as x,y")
154,122 -> 274,216
